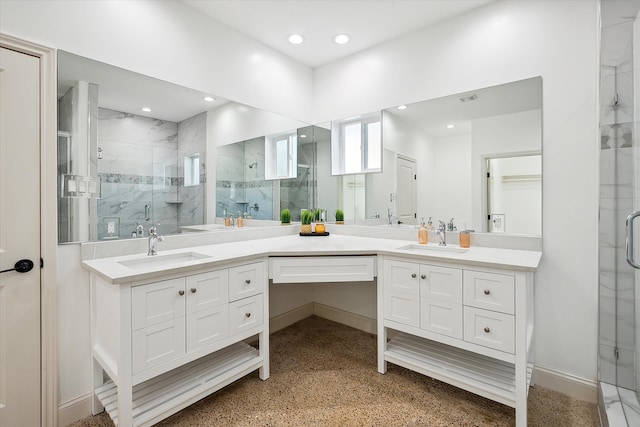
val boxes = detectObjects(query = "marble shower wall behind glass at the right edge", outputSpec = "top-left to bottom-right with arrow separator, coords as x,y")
599,18 -> 636,390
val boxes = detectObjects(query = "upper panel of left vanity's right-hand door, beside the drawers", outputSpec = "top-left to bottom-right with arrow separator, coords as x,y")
185,270 -> 229,313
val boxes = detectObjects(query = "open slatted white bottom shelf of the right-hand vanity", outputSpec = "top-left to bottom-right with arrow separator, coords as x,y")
384,333 -> 516,407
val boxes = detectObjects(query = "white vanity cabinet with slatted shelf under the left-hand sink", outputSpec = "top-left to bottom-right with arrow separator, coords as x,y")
91,260 -> 269,426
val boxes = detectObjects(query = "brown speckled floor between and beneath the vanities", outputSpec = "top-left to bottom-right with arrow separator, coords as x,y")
72,316 -> 598,427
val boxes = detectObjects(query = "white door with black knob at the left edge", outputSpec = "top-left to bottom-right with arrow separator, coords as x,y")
0,48 -> 40,426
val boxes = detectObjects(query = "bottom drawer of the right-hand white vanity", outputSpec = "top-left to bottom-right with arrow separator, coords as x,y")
464,307 -> 515,354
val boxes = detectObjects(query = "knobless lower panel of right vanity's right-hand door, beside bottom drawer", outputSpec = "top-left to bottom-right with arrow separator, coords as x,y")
420,298 -> 462,339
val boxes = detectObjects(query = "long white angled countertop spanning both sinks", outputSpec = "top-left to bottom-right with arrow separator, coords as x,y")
82,234 -> 542,284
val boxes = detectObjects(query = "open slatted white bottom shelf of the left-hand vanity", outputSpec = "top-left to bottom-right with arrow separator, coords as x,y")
95,342 -> 263,426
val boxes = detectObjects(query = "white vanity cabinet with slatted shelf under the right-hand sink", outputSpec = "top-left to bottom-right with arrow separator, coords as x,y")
378,256 -> 533,427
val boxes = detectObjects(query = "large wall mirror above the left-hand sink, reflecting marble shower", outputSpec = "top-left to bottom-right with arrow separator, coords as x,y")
58,51 -> 306,243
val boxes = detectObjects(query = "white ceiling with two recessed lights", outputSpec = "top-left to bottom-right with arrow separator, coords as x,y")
181,0 -> 493,68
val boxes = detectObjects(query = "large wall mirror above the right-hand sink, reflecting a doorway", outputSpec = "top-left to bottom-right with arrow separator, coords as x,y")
348,77 -> 542,235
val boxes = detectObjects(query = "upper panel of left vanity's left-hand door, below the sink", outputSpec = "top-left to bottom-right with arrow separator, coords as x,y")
131,277 -> 185,331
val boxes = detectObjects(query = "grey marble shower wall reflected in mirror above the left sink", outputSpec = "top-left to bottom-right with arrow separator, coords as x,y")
98,108 -> 206,239
